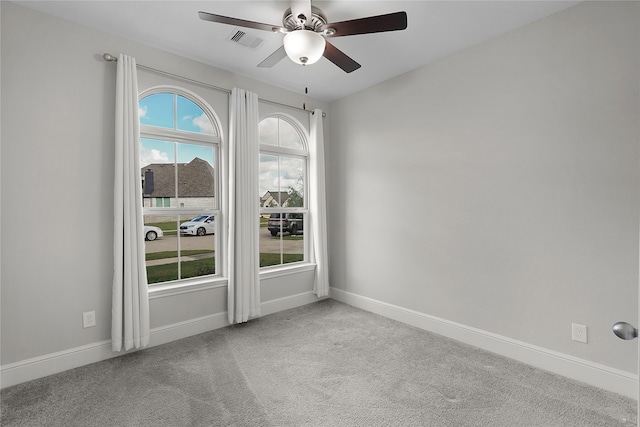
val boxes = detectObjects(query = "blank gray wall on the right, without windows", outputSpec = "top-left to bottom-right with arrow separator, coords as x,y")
326,2 -> 640,372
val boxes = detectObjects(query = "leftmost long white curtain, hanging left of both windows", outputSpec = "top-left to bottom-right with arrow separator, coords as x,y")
111,55 -> 149,351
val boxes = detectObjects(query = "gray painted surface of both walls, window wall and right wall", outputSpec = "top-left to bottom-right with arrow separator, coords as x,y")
0,2 -> 640,382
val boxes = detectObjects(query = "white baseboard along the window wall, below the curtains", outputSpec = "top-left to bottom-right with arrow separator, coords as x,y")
0,292 -> 319,388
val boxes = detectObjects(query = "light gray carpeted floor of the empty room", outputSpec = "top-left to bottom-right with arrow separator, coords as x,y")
0,300 -> 636,427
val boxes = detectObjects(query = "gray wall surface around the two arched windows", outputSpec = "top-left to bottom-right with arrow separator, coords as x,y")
0,2 -> 327,365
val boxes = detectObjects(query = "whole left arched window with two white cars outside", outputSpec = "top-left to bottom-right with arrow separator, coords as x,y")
139,87 -> 221,284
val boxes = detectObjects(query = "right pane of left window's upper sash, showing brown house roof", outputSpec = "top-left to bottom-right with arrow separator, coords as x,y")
177,143 -> 215,209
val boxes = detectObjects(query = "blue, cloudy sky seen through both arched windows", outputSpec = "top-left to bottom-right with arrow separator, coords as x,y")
138,93 -> 305,196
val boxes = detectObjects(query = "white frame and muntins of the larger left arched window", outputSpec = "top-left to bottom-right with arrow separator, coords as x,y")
138,85 -> 226,290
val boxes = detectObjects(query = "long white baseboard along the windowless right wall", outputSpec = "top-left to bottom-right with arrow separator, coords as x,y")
330,288 -> 638,399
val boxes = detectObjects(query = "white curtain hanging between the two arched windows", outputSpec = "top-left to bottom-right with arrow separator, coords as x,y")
227,88 -> 260,323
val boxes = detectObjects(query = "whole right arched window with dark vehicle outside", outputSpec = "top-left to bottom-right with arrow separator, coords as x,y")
259,114 -> 309,267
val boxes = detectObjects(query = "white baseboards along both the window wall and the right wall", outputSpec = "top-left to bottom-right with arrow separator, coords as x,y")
6,288 -> 638,399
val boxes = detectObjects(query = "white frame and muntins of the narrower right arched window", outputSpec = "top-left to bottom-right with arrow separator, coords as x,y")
258,113 -> 311,270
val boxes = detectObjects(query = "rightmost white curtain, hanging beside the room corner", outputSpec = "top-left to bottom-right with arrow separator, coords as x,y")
309,109 -> 329,297
